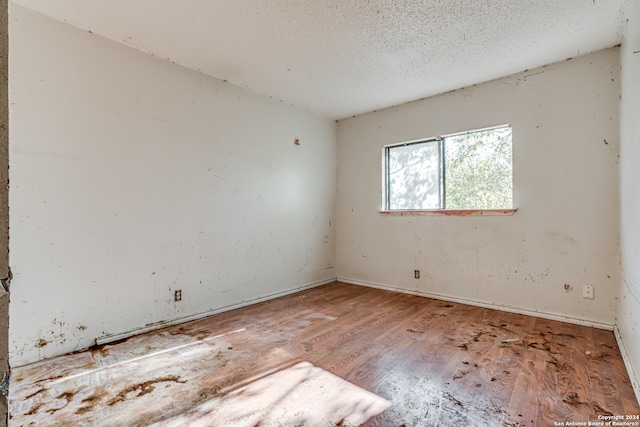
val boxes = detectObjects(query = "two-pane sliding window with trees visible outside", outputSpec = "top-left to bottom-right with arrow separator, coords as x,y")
384,125 -> 513,210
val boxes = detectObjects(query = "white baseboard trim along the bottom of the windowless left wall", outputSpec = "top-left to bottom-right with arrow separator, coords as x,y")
95,277 -> 337,345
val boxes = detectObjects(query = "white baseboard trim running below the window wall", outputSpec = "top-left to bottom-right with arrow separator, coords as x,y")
338,277 -> 614,331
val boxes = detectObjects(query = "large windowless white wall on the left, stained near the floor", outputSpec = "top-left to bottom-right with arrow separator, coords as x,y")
10,5 -> 336,366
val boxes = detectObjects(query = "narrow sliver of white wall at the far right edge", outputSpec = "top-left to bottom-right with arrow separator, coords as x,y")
616,2 -> 640,400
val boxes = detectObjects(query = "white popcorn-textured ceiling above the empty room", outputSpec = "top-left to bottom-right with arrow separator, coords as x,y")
13,0 -> 637,119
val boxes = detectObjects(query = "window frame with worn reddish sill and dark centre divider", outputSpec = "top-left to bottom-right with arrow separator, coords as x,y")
380,123 -> 518,216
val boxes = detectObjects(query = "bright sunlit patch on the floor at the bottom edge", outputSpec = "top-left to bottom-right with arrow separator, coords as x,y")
154,362 -> 391,427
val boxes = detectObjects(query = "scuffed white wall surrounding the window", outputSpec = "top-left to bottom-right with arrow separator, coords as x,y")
337,48 -> 619,327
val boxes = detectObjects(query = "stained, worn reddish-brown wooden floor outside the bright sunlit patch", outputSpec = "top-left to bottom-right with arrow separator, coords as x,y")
10,283 -> 640,427
